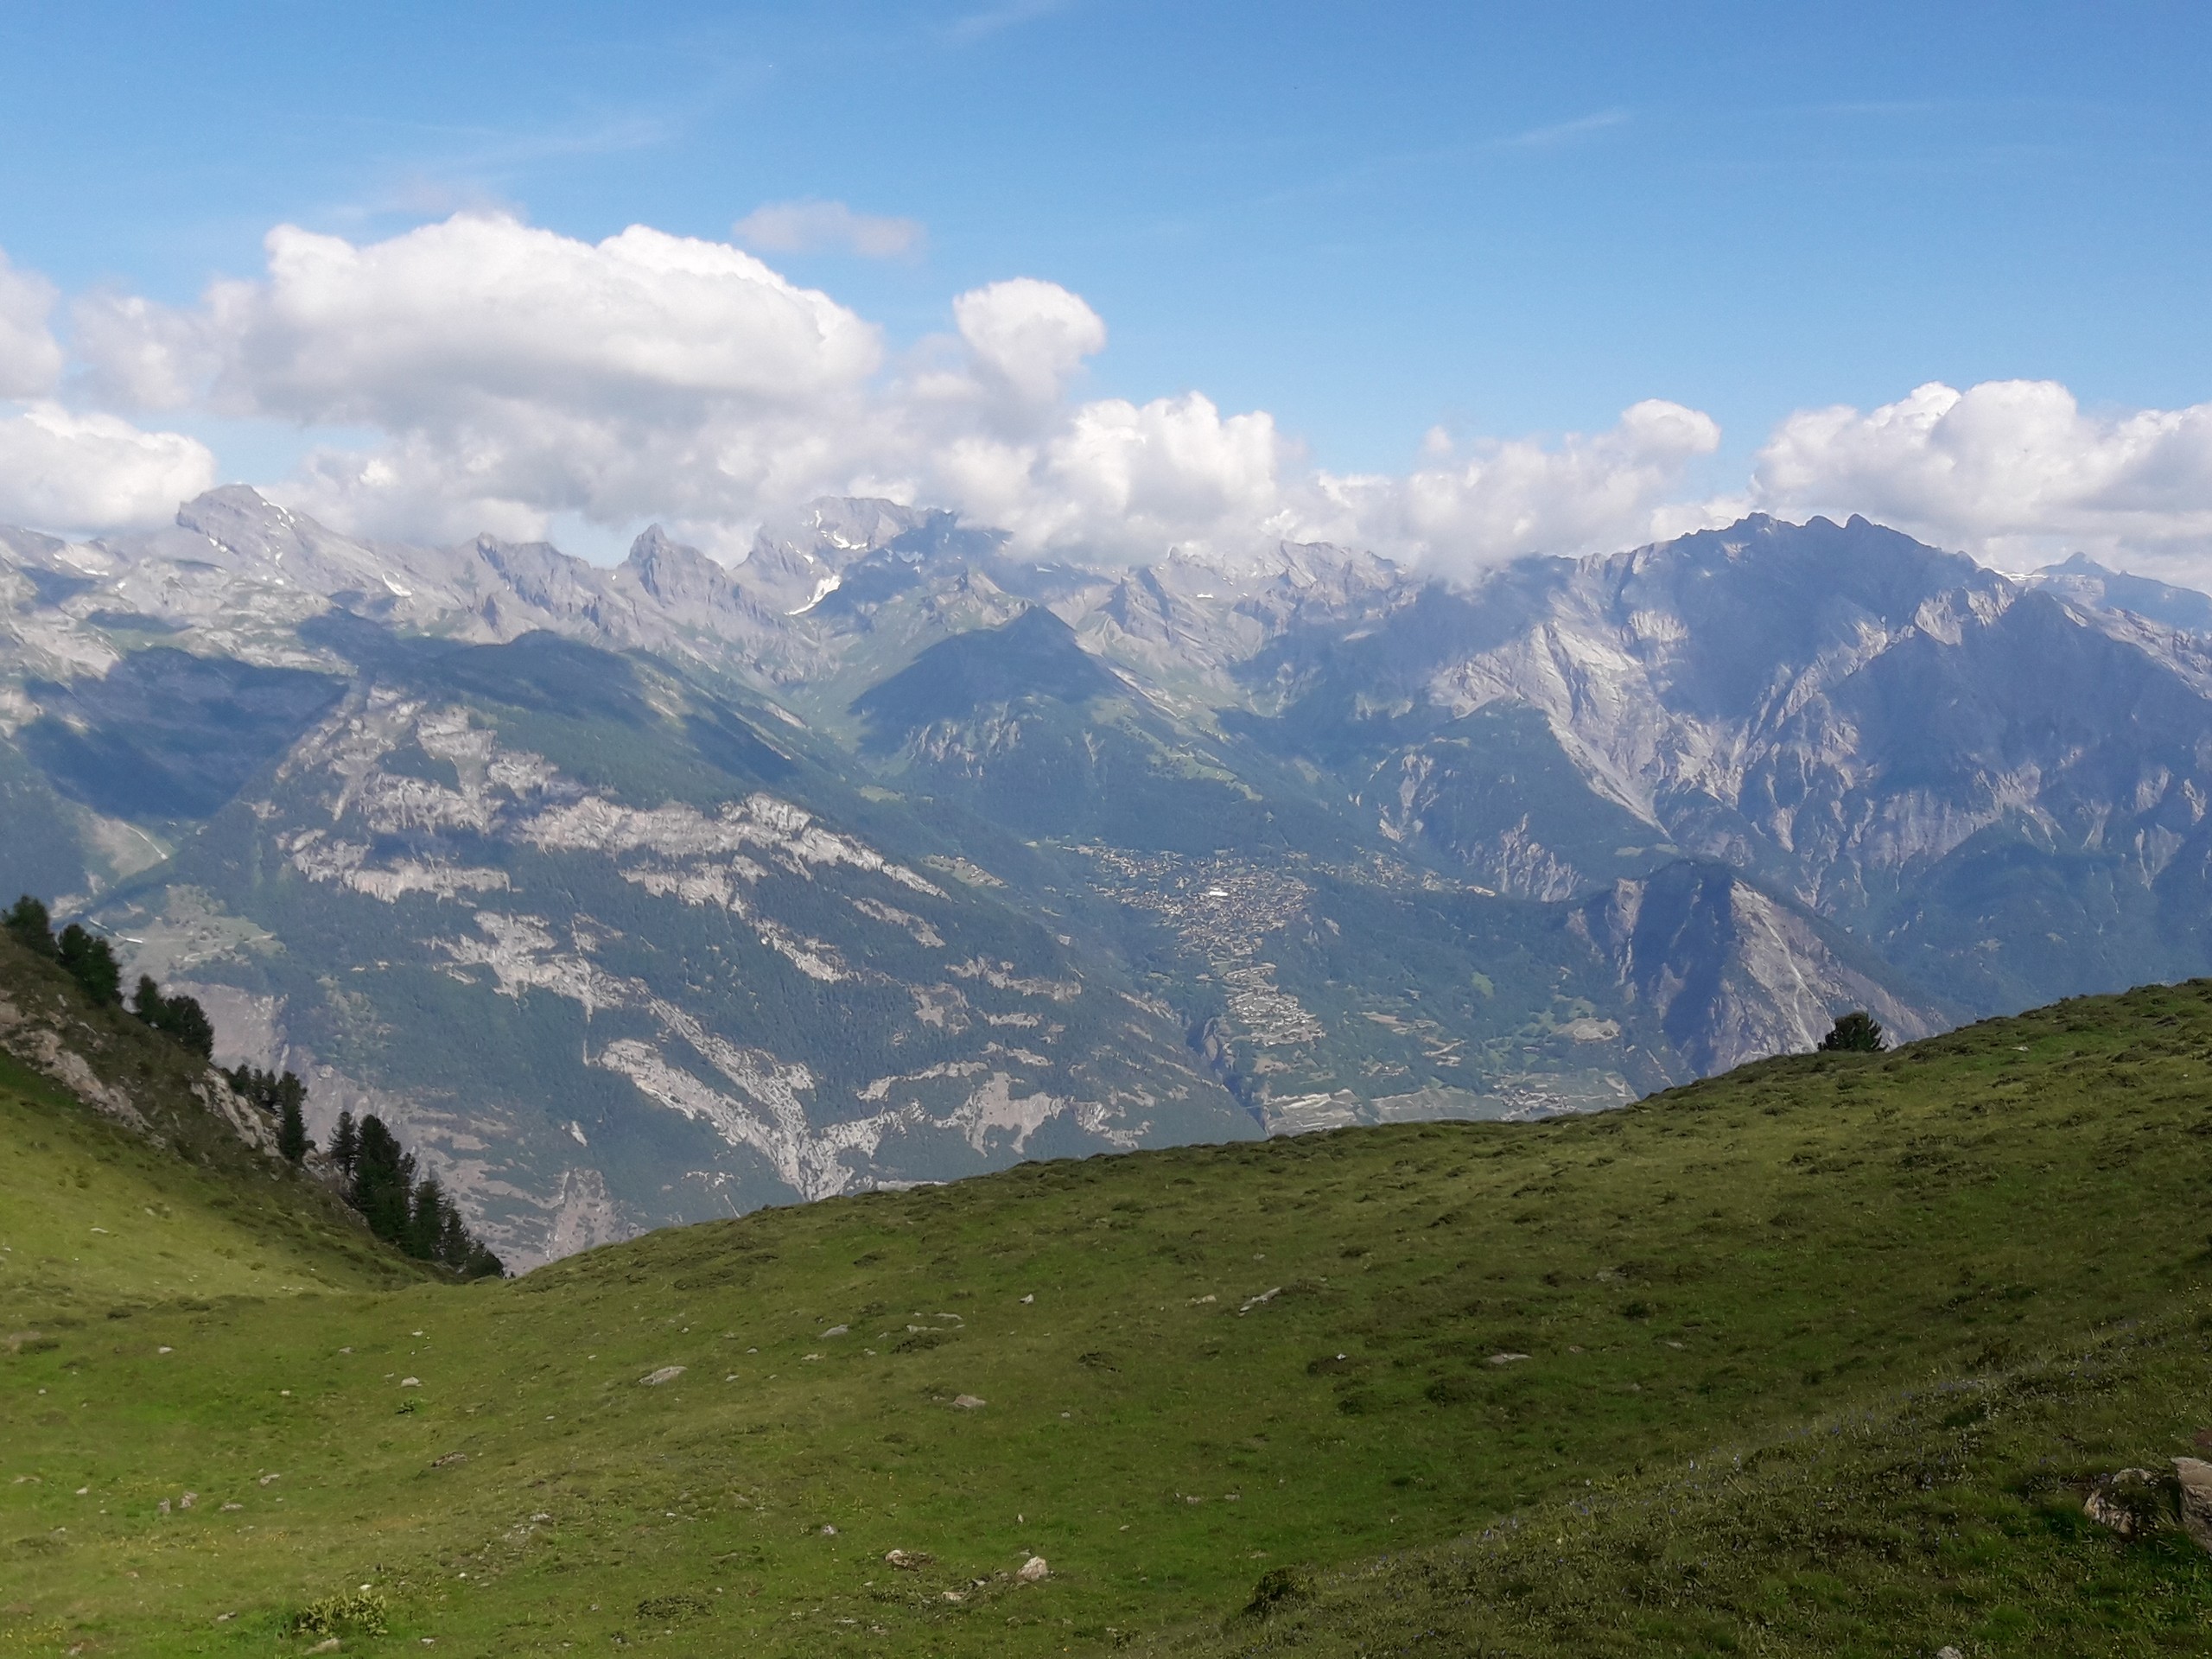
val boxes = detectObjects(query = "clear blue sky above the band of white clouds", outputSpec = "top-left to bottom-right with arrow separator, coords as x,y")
0,0 -> 2212,570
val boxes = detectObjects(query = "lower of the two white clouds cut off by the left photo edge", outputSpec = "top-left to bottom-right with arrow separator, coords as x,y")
0,403 -> 214,531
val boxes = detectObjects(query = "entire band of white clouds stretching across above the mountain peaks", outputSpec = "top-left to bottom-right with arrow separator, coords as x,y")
13,204 -> 2212,580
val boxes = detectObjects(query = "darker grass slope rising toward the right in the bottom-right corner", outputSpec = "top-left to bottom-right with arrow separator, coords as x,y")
1159,1312 -> 2212,1659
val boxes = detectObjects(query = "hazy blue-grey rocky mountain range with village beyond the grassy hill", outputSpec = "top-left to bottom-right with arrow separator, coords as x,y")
0,489 -> 2212,1261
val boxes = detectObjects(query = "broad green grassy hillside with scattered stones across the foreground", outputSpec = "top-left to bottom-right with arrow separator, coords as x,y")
0,984 -> 2212,1655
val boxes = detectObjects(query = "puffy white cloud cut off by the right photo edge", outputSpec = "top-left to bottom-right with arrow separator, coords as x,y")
1752,380 -> 2212,580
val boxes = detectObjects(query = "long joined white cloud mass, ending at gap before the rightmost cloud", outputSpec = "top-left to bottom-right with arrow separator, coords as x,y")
55,214 -> 1717,566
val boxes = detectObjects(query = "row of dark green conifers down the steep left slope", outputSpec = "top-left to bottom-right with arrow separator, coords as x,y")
0,893 -> 506,1279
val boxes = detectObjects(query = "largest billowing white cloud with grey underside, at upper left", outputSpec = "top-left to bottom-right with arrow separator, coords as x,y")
79,214 -> 882,546
